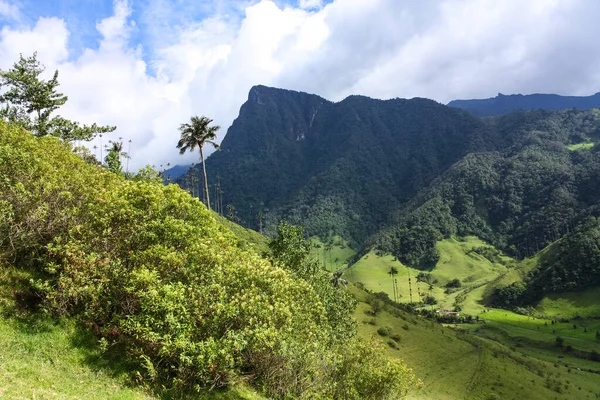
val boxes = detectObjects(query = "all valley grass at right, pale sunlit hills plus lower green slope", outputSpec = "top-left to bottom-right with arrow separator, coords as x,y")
345,237 -> 600,399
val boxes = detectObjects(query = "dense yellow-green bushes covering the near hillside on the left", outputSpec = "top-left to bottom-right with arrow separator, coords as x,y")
0,123 -> 414,398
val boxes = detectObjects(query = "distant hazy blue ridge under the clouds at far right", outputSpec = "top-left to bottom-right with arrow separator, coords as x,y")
448,93 -> 600,117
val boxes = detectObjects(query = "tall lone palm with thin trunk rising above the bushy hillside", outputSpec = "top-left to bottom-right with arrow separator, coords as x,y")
177,116 -> 220,210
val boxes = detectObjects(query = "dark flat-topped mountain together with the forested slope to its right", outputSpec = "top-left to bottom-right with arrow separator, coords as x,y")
180,86 -> 600,296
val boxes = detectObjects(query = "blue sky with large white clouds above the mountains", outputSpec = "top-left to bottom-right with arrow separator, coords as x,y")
0,0 -> 600,169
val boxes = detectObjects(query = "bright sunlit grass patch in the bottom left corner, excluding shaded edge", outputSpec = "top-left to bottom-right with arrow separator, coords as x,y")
0,317 -> 154,399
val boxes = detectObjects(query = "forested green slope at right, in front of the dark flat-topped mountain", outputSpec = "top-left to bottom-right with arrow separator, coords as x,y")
370,110 -> 600,266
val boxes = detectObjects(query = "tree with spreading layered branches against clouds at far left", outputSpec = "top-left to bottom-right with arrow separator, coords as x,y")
0,53 -> 116,142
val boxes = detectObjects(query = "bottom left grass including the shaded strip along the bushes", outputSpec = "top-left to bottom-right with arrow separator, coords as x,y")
0,264 -> 263,400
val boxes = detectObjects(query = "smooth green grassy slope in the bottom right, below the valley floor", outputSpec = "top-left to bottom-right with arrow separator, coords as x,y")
355,284 -> 600,400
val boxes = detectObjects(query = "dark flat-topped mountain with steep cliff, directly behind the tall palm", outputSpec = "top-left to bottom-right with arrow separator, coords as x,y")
190,86 -> 495,245
